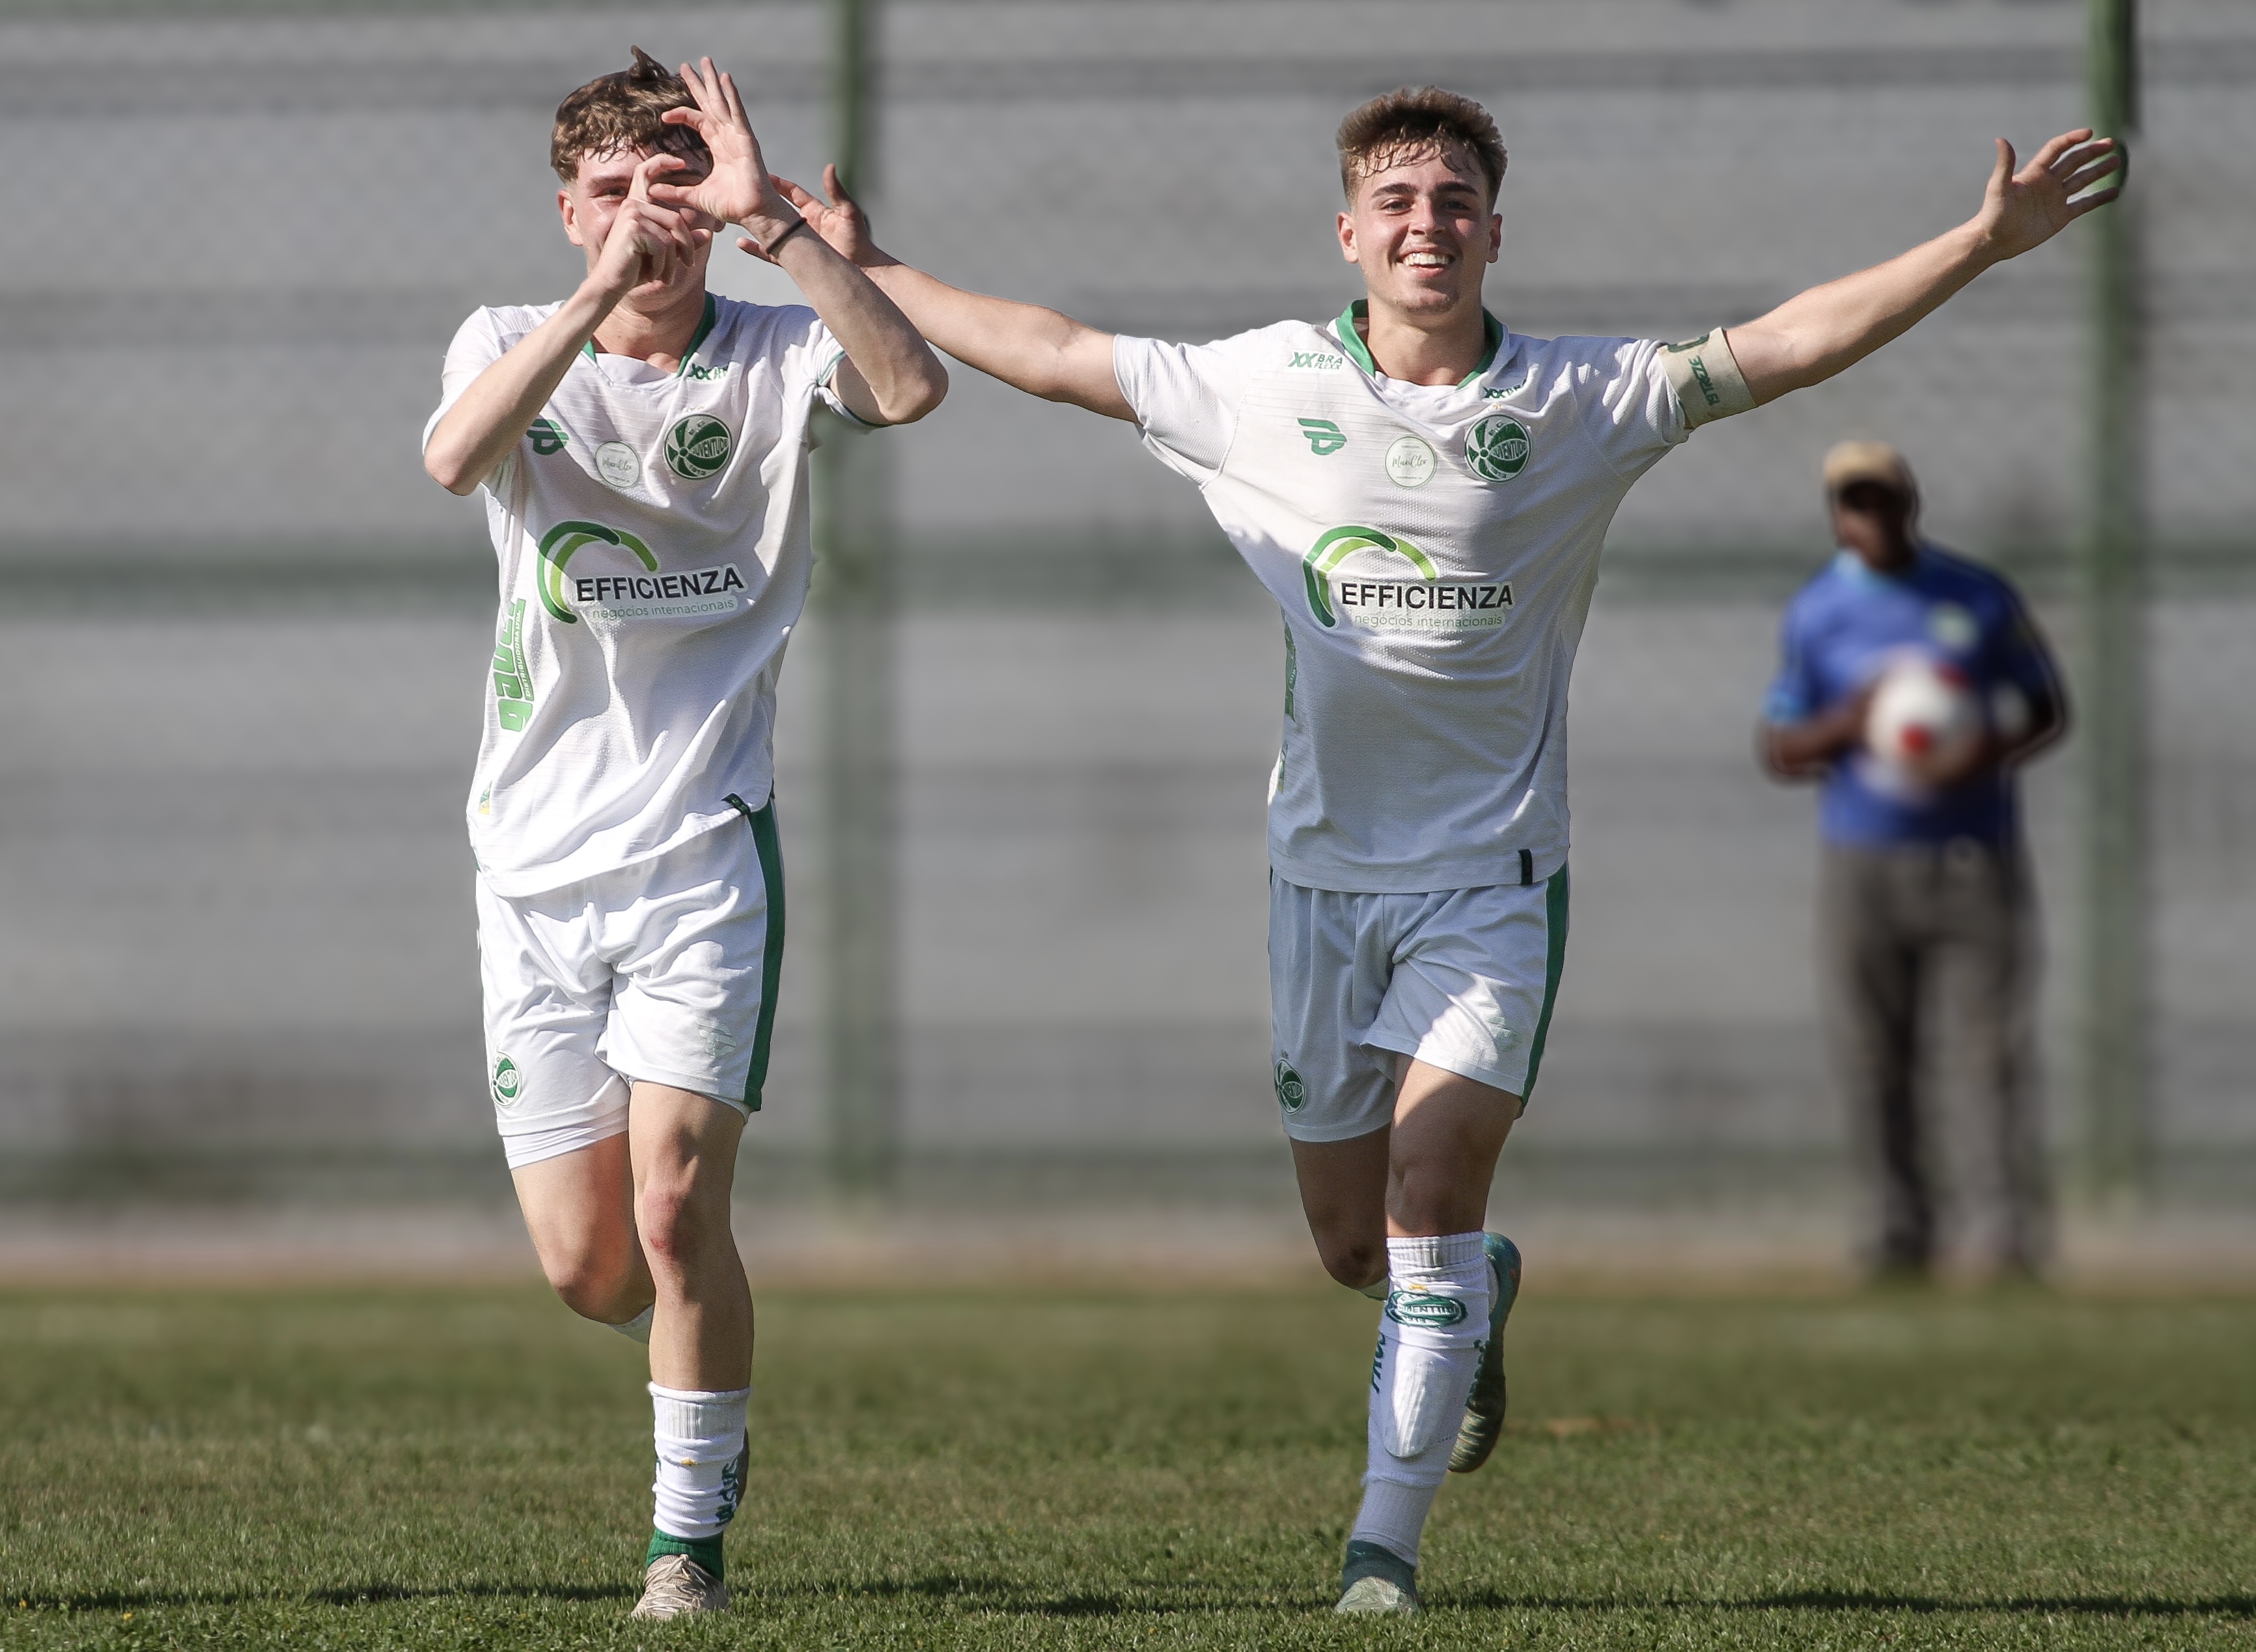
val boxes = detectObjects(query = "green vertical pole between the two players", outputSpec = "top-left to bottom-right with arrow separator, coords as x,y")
815,0 -> 898,1198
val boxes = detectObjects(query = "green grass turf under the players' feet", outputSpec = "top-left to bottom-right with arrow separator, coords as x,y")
0,1291 -> 2256,1652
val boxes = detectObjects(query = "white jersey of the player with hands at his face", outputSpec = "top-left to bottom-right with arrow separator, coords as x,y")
424,298 -> 853,896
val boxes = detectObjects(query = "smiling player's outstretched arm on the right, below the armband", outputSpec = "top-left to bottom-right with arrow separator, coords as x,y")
1726,129 -> 2123,404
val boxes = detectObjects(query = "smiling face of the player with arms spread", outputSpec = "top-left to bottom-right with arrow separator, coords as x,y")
1340,147 -> 1505,316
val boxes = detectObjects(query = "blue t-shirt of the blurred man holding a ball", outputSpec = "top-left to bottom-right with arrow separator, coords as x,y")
1762,544 -> 2062,848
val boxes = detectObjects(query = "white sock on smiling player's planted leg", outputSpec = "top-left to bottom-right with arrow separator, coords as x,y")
1349,1232 -> 1494,1566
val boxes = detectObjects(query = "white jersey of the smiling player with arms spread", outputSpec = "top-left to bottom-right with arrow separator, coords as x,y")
1112,300 -> 1690,893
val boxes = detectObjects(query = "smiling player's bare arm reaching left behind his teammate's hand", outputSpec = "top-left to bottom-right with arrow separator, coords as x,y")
767,167 -> 1135,422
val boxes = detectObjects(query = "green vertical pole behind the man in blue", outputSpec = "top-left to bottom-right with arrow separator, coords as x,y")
2078,0 -> 2150,1203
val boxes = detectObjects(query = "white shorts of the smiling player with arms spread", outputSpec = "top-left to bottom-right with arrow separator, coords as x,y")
1270,867 -> 1568,1142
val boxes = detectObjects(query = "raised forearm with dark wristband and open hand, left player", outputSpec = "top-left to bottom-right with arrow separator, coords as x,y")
650,57 -> 947,425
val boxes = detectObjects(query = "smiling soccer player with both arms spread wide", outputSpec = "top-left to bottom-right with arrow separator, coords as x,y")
767,88 -> 2121,1612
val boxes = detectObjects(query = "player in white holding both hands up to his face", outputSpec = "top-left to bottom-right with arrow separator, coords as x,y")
424,49 -> 947,1618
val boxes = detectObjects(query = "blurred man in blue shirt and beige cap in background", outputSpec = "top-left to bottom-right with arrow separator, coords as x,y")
1762,442 -> 2067,1275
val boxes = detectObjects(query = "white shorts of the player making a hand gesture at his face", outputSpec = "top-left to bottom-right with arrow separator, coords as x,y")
479,796 -> 783,1169
